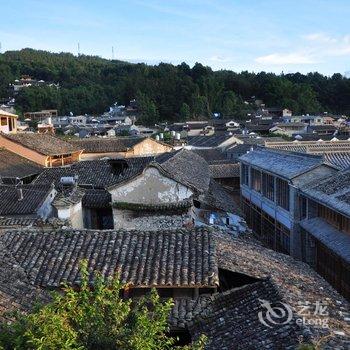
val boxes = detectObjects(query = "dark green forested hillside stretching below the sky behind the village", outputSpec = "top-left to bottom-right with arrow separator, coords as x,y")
0,49 -> 350,123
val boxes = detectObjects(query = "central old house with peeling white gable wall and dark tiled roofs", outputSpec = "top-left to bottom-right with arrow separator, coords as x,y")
34,150 -> 244,229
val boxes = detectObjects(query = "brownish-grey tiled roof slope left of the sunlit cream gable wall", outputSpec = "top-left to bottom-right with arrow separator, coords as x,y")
69,136 -> 145,153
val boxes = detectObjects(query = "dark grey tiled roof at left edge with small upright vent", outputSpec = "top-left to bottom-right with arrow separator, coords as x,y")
0,184 -> 52,216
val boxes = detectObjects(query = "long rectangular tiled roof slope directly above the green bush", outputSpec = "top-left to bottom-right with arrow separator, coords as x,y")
0,228 -> 218,288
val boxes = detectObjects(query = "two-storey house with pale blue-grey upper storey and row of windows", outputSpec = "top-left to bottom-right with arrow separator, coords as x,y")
240,147 -> 337,259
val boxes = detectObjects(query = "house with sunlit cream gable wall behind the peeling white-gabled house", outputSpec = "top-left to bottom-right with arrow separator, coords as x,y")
70,137 -> 173,160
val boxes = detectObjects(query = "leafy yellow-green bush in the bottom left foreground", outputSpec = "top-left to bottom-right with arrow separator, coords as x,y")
0,263 -> 204,350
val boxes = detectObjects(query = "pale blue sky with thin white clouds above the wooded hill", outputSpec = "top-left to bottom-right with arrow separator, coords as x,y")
0,0 -> 350,76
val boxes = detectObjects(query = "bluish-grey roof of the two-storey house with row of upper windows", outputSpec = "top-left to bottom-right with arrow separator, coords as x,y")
240,147 -> 322,179
